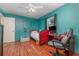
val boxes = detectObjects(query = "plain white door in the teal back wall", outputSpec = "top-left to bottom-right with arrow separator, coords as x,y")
1,17 -> 15,42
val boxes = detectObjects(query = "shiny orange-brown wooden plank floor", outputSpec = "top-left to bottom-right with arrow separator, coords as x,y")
3,40 -> 64,56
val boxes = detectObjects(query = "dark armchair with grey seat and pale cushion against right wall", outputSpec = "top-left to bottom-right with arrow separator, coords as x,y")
48,29 -> 73,56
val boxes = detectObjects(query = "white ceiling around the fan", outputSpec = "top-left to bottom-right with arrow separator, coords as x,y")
0,3 -> 64,18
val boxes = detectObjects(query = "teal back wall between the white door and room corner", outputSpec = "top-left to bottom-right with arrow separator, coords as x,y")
0,10 -> 38,41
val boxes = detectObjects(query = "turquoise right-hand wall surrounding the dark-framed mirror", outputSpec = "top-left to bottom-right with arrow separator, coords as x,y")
39,3 -> 79,53
